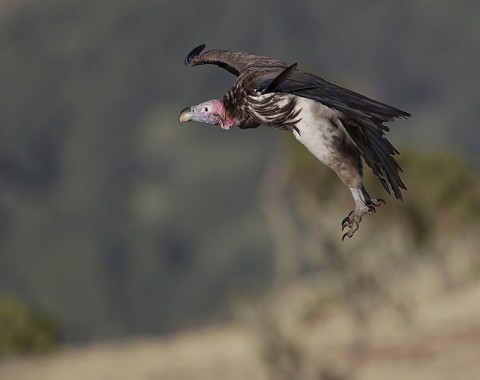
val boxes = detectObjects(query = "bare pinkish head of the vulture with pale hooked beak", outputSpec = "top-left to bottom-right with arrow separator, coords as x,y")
178,99 -> 236,129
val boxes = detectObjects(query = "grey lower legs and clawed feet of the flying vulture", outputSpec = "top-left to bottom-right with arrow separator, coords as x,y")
342,185 -> 385,241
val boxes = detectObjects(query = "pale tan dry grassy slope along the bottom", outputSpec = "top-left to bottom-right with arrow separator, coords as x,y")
0,283 -> 480,380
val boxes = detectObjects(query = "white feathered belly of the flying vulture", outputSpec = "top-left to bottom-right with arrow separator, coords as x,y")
293,97 -> 345,169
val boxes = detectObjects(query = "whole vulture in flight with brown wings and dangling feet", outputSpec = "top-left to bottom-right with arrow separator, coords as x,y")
178,44 -> 411,240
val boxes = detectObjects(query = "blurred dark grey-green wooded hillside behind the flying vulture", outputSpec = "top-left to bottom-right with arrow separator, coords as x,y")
0,0 -> 480,348
